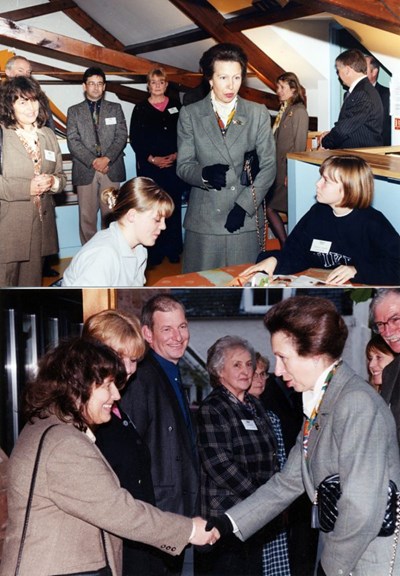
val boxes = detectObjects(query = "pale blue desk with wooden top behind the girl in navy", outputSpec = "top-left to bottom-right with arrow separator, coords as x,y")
288,146 -> 400,233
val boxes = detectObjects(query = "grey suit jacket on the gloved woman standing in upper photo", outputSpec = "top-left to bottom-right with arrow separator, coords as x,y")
177,95 -> 276,235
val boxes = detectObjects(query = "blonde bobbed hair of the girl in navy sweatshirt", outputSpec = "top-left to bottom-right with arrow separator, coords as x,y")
319,154 -> 374,208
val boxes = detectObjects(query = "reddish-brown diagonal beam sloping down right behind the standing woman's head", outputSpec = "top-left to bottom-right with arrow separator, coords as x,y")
170,0 -> 285,99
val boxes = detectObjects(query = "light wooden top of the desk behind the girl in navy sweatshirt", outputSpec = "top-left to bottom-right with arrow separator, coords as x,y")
288,146 -> 400,180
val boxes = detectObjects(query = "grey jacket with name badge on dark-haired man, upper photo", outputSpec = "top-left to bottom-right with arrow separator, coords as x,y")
67,99 -> 128,186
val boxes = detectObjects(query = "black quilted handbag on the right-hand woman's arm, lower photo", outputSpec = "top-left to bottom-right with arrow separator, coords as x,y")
314,474 -> 399,536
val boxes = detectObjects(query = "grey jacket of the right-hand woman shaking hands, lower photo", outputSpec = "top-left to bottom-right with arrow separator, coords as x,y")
227,364 -> 400,576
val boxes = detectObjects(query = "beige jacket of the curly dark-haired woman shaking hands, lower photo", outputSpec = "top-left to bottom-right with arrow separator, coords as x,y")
0,416 -> 192,576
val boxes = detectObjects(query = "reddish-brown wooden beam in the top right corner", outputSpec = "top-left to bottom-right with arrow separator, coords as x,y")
296,0 -> 400,35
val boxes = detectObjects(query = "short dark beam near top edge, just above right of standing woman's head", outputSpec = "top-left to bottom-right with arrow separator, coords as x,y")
225,2 -> 321,32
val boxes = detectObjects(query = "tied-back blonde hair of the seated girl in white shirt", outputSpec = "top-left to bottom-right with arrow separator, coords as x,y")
101,176 -> 175,220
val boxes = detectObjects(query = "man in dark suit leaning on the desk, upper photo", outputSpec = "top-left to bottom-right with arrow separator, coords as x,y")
321,49 -> 383,149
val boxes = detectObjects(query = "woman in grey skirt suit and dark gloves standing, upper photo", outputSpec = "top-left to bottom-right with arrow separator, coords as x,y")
177,44 -> 276,272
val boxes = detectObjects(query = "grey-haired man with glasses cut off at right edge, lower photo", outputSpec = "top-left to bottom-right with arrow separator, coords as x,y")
370,288 -> 400,444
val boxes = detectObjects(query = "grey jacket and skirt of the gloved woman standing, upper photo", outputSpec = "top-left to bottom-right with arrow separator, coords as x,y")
177,95 -> 276,272
